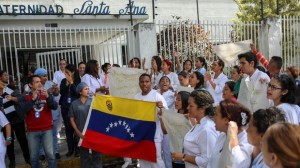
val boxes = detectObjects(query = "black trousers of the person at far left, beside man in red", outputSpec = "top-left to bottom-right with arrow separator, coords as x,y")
4,121 -> 30,163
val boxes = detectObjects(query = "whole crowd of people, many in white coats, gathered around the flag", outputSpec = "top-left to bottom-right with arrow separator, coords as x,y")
0,45 -> 300,168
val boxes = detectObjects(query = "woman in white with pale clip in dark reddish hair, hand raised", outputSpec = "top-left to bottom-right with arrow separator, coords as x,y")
207,100 -> 253,168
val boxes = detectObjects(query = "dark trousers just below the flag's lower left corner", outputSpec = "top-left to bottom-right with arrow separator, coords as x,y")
80,147 -> 103,168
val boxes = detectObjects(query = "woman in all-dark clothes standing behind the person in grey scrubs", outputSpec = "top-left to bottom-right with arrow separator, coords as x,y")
59,64 -> 81,157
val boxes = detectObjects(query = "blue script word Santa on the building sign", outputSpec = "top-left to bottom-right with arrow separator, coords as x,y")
74,0 -> 110,15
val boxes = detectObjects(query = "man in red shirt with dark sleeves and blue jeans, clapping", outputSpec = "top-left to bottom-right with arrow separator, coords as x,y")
19,75 -> 58,168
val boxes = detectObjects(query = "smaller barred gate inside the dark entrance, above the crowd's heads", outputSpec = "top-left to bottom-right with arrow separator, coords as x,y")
36,49 -> 83,80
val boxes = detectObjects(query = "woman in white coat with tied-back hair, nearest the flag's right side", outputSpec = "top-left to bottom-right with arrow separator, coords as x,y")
172,89 -> 219,168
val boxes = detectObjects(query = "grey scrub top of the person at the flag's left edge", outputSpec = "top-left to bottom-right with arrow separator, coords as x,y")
69,98 -> 93,132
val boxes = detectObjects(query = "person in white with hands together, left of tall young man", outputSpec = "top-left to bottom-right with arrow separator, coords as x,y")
204,60 -> 228,107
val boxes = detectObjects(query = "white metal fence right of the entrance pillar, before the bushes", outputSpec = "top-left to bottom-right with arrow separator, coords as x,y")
156,17 -> 300,71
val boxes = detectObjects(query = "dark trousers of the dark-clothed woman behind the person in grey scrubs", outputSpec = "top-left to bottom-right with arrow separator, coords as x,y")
61,107 -> 78,152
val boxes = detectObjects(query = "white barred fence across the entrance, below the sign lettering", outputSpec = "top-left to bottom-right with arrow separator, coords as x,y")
0,26 -> 136,89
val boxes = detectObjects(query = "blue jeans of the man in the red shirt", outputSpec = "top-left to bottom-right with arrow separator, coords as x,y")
27,129 -> 57,168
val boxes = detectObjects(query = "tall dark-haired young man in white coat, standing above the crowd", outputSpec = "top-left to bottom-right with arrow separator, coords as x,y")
238,52 -> 270,113
